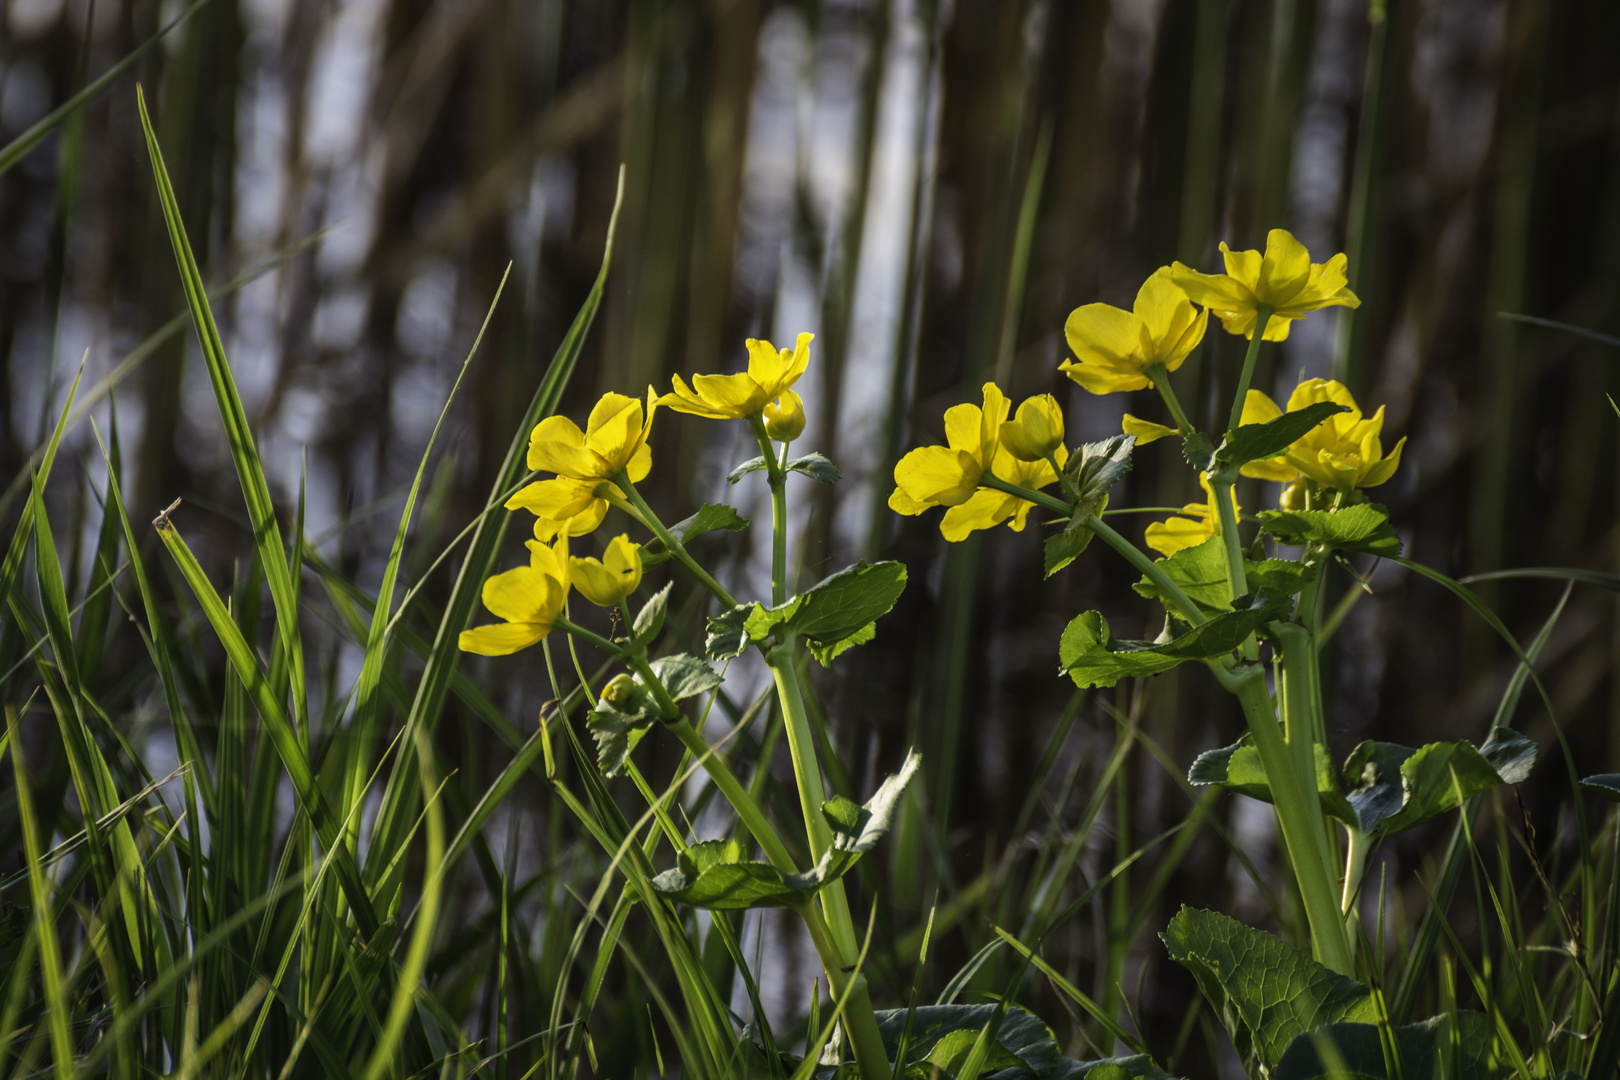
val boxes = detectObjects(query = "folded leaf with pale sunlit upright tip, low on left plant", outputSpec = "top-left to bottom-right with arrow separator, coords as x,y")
653,751 -> 922,912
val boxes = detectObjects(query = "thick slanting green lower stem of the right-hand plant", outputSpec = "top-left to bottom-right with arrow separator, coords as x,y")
1209,661 -> 1353,975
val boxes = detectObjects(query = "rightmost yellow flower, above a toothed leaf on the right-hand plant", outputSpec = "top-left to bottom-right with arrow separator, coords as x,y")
1241,379 -> 1406,491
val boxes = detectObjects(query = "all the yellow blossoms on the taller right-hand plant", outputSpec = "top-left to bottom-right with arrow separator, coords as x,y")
889,228 -> 1405,555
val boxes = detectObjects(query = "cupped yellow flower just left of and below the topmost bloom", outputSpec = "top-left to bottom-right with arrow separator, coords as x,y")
1058,266 -> 1209,393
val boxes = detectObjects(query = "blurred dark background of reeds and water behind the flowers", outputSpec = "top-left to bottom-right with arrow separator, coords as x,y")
0,0 -> 1620,1062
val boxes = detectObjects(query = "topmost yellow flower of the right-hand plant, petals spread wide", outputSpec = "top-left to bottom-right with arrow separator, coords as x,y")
1171,228 -> 1361,342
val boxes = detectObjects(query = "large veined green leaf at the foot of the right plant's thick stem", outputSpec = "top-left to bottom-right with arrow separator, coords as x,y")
1160,907 -> 1377,1075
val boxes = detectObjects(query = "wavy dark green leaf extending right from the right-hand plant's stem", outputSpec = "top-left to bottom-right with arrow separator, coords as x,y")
1345,729 -> 1536,836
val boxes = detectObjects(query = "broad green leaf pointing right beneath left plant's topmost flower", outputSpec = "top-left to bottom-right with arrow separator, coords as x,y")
738,560 -> 906,664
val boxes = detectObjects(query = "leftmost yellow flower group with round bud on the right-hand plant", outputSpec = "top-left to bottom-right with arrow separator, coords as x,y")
889,382 -> 1068,541
